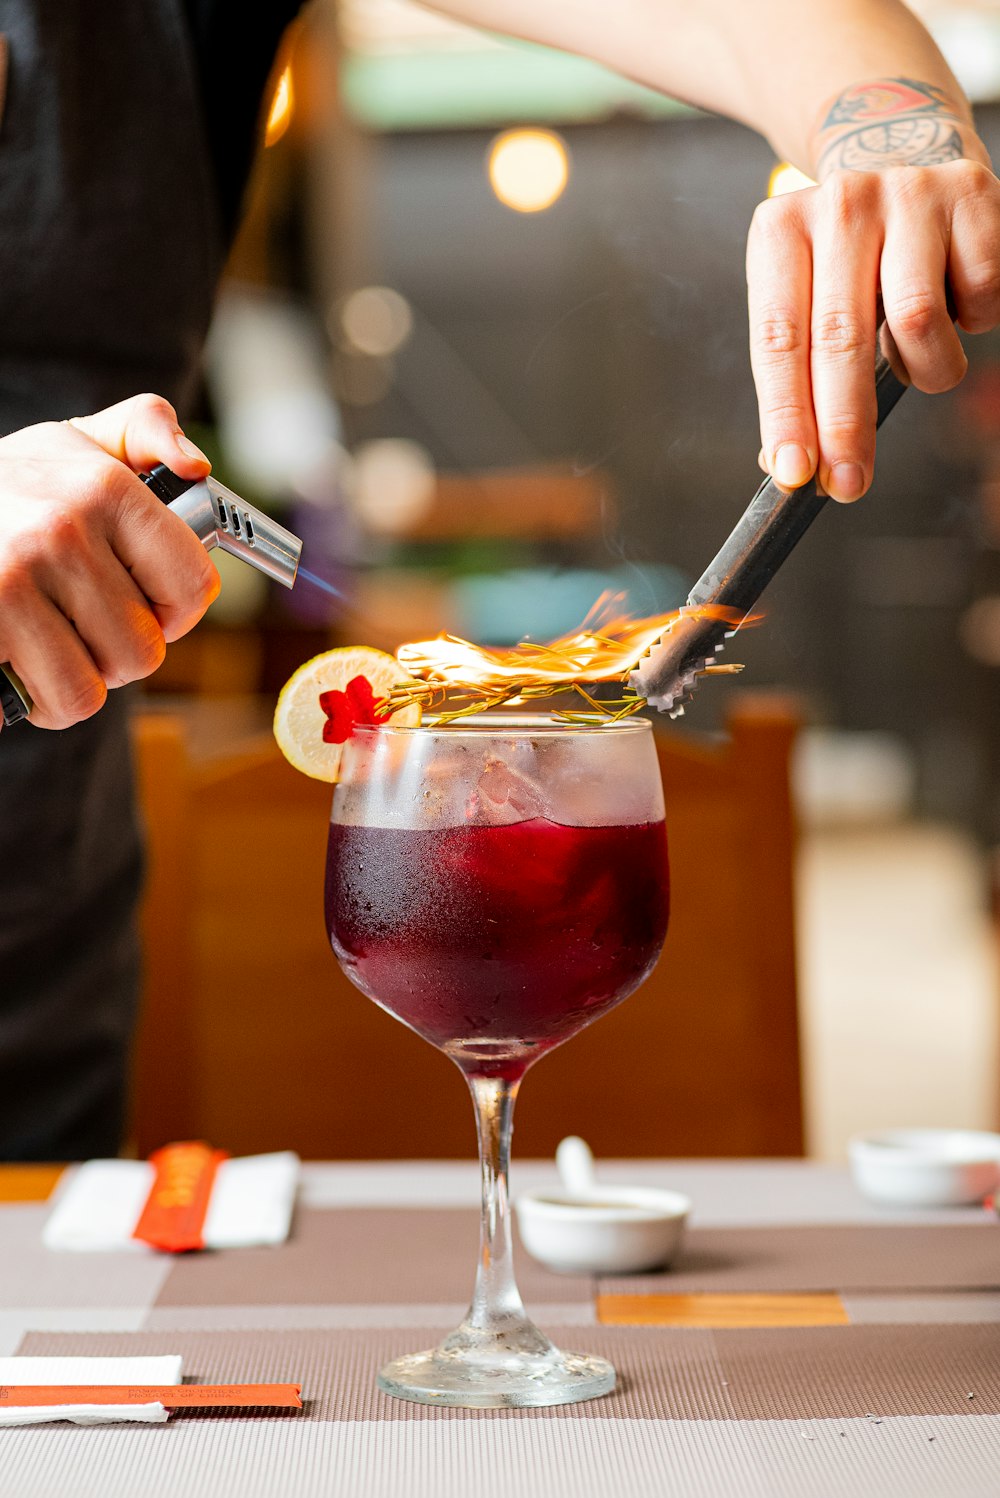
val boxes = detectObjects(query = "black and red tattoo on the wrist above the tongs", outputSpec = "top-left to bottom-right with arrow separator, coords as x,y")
817,78 -> 966,175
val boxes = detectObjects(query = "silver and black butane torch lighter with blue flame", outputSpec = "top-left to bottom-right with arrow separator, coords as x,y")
0,463 -> 302,725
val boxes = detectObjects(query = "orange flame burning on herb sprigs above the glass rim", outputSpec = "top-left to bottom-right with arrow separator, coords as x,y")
391,593 -> 753,715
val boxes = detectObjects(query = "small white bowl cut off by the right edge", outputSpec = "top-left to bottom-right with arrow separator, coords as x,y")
847,1128 -> 1000,1207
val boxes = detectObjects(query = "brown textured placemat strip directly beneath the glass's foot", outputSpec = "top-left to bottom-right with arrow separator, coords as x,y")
19,1326 -> 1000,1426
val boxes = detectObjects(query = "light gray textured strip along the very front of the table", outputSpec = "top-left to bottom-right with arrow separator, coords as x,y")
0,1414 -> 1000,1498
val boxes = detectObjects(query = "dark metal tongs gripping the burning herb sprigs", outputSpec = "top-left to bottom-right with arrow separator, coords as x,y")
629,331 -> 907,718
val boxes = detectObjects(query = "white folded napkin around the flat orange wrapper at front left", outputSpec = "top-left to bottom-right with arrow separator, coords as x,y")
0,1356 -> 181,1426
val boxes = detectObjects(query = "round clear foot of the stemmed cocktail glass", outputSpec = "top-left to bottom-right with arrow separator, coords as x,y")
379,1323 -> 615,1410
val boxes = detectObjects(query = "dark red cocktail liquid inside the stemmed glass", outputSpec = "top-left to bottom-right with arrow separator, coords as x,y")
326,816 -> 668,1077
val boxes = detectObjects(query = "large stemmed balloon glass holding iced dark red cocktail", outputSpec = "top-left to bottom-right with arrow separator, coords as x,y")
326,713 -> 669,1407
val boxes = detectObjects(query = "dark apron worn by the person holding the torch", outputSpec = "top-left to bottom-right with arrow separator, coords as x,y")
0,0 -> 223,1159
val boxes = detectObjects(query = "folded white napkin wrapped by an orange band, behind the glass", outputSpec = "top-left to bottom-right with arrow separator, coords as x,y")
42,1150 -> 301,1254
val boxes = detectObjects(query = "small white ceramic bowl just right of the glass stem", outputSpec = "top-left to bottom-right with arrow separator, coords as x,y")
515,1186 -> 692,1275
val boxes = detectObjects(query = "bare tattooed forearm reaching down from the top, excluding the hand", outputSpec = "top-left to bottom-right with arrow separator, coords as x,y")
433,0 -> 988,177
